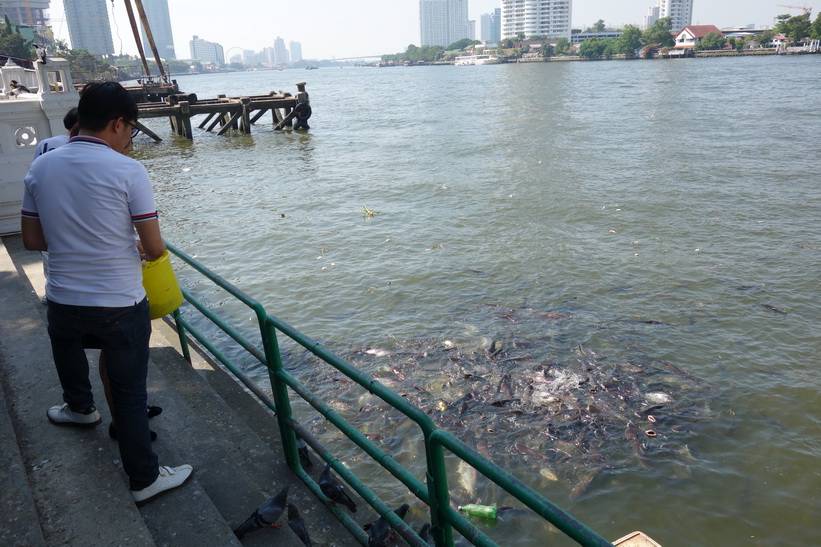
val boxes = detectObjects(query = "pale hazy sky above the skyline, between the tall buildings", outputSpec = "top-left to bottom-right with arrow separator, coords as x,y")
51,0 -> 820,59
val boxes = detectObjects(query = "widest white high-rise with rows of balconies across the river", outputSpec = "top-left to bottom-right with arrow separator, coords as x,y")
502,0 -> 573,40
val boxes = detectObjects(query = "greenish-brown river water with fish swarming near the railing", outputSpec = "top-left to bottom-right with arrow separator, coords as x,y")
135,55 -> 821,546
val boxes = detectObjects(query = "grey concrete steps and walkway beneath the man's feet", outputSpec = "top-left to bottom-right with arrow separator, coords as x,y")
0,236 -> 358,546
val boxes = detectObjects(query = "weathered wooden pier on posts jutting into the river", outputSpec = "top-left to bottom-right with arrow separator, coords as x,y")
137,82 -> 311,141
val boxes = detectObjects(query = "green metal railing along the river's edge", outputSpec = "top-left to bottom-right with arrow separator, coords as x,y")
167,244 -> 612,546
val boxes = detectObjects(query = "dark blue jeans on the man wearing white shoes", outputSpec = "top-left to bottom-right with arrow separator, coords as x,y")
48,299 -> 159,490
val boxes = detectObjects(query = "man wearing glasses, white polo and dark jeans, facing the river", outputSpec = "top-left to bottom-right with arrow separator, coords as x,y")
21,82 -> 192,504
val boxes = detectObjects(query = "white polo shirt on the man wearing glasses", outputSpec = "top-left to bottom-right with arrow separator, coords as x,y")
21,136 -> 157,308
